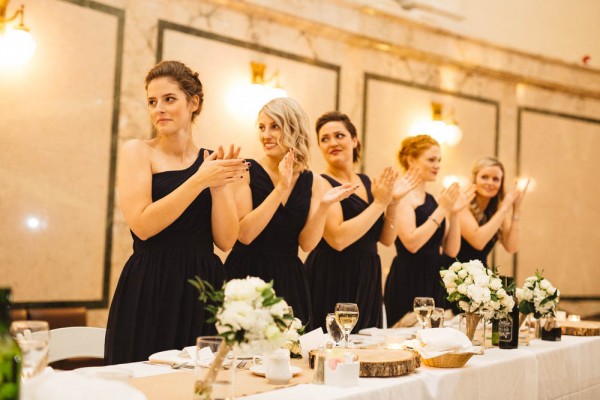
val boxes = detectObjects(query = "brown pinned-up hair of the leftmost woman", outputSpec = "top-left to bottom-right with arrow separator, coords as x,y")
146,61 -> 204,121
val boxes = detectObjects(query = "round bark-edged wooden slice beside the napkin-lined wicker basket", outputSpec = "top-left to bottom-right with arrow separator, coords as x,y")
310,348 -> 421,378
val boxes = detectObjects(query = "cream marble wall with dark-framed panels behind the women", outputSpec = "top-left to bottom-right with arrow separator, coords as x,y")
0,0 -> 600,327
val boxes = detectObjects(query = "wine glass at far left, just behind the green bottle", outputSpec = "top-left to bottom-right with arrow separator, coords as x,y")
10,321 -> 50,379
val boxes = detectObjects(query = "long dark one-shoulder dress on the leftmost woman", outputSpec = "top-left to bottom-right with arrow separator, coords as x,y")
104,149 -> 225,364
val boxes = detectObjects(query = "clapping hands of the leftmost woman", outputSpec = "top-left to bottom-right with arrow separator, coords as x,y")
194,146 -> 250,188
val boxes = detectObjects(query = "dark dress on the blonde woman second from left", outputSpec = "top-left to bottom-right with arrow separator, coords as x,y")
225,160 -> 313,324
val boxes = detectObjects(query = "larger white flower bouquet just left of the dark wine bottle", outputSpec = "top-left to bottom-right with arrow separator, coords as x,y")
440,260 -> 515,319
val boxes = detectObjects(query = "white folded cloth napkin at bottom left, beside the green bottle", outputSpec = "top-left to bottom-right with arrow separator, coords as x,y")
21,371 -> 146,400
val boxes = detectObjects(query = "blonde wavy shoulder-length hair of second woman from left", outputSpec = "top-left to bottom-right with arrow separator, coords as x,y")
258,97 -> 310,171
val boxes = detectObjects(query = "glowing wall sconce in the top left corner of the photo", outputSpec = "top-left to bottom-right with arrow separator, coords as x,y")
0,0 -> 35,65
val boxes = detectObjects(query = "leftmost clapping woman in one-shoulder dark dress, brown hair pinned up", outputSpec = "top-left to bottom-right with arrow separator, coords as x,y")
105,61 -> 248,364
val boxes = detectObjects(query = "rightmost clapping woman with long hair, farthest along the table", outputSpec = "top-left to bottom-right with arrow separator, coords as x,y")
456,157 -> 529,266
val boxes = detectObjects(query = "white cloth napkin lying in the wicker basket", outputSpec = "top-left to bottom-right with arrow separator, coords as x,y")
404,328 -> 475,358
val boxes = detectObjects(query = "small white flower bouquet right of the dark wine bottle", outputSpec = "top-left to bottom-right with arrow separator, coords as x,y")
516,271 -> 560,319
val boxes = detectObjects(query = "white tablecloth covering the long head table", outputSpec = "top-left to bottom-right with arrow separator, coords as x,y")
24,336 -> 600,400
